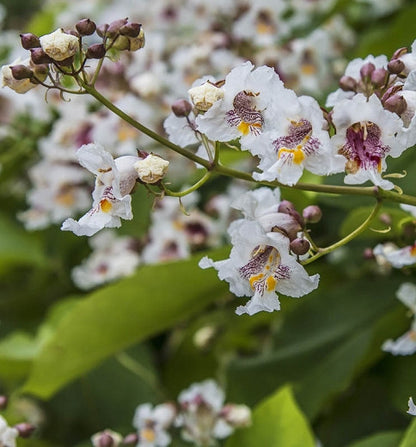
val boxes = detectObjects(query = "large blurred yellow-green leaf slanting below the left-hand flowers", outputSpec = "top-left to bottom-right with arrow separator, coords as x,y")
23,250 -> 226,398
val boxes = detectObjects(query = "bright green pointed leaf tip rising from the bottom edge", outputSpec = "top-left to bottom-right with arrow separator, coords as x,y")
226,386 -> 315,447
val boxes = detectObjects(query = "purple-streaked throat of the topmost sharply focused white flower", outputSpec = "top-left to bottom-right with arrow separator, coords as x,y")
226,90 -> 263,135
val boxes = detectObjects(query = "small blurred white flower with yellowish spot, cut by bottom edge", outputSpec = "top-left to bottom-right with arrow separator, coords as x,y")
133,403 -> 176,447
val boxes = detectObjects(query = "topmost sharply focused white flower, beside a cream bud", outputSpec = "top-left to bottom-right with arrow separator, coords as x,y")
196,62 -> 286,149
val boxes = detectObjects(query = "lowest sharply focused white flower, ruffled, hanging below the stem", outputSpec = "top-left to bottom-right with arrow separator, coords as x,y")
199,219 -> 319,315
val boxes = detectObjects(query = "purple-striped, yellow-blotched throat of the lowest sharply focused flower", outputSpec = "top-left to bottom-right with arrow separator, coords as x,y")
239,245 -> 290,295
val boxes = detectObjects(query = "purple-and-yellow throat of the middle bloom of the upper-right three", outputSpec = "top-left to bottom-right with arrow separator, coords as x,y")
273,119 -> 321,165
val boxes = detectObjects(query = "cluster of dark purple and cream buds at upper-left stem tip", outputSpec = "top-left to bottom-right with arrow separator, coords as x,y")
2,18 -> 144,93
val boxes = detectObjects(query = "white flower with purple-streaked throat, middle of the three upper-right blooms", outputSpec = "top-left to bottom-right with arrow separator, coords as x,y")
250,92 -> 343,185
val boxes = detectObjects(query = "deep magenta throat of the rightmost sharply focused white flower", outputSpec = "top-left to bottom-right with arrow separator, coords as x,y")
338,121 -> 390,174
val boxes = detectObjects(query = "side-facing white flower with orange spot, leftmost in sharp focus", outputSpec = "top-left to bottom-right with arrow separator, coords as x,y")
61,144 -> 138,236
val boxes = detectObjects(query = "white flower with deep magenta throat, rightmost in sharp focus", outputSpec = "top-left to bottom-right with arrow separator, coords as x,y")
332,94 -> 407,189
